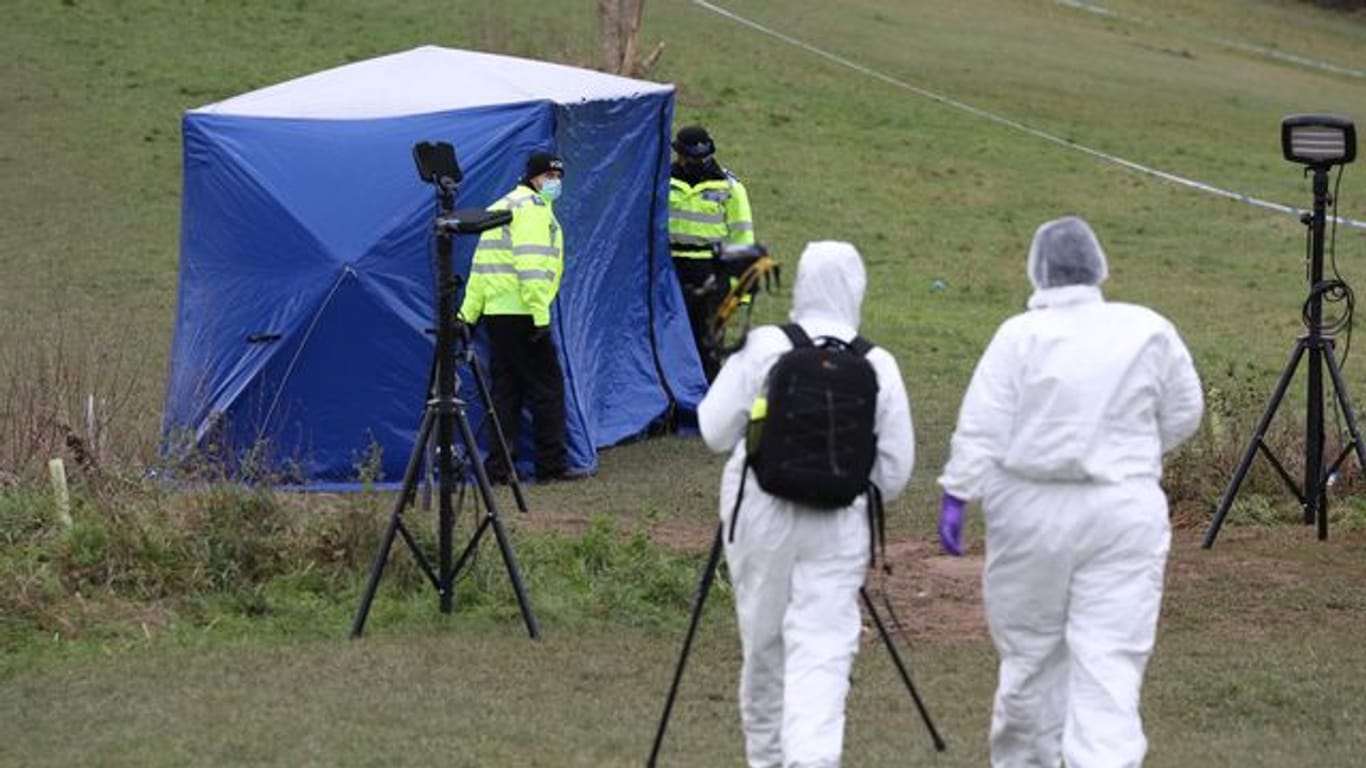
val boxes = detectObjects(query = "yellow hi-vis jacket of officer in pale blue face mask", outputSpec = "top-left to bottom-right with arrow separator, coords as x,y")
460,184 -> 564,327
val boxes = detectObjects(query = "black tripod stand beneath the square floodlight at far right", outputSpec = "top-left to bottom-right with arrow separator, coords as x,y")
1203,128 -> 1366,549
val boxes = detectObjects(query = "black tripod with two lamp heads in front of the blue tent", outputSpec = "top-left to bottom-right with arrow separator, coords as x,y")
351,142 -> 541,640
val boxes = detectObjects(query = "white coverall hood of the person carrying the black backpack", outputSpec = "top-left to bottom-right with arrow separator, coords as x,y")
788,241 -> 867,336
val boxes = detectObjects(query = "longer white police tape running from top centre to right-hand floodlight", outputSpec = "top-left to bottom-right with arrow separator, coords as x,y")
693,0 -> 1366,230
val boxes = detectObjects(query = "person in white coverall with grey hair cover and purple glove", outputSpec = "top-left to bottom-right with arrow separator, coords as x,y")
940,217 -> 1203,768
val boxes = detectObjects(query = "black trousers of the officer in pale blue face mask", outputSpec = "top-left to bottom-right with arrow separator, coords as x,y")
482,314 -> 568,481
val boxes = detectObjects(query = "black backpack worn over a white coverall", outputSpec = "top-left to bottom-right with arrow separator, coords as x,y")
747,324 -> 877,510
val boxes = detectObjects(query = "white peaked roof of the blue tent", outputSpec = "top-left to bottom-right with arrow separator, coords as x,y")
193,45 -> 673,120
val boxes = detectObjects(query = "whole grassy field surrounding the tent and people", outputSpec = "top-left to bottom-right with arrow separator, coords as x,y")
0,0 -> 1366,767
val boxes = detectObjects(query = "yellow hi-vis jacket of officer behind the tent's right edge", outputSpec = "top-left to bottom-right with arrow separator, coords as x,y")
669,171 -> 754,258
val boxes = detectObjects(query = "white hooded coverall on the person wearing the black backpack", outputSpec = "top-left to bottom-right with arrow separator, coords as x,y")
698,242 -> 915,768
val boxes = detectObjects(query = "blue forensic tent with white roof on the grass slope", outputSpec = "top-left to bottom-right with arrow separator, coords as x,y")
164,46 -> 706,486
